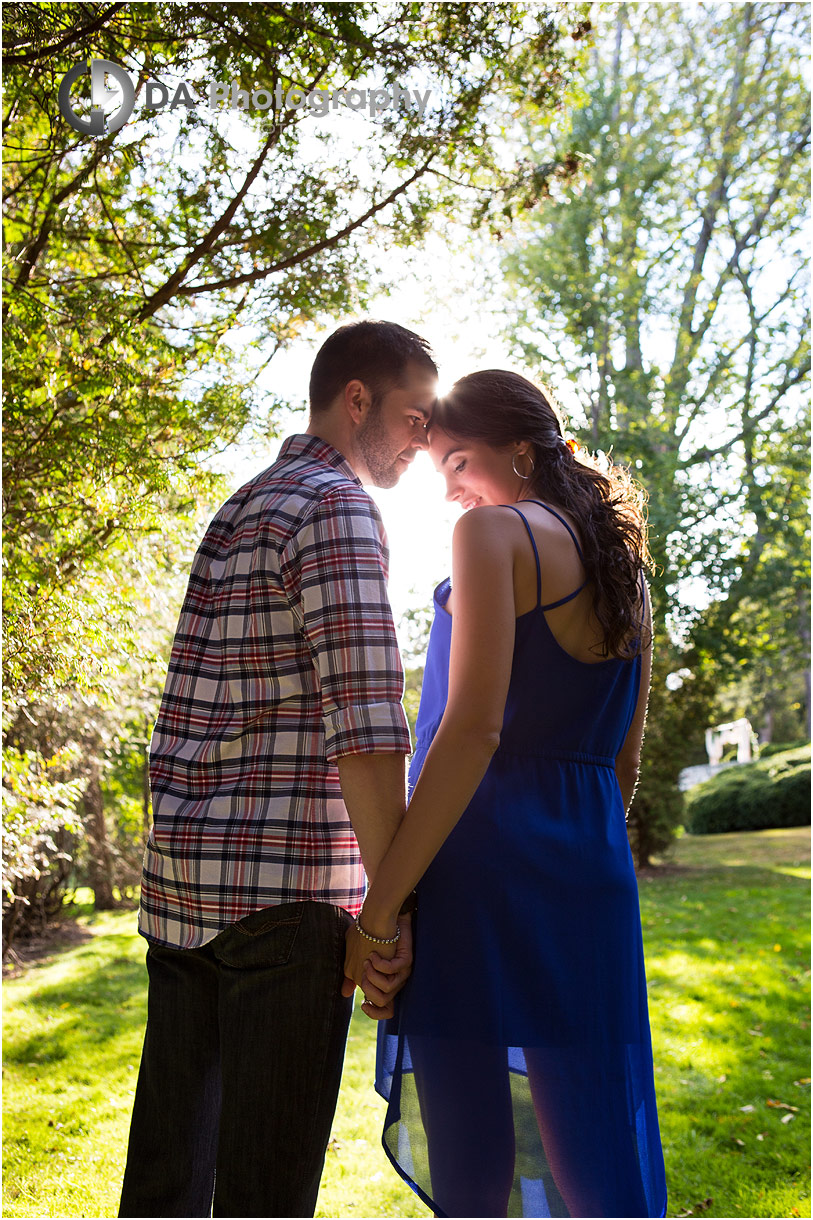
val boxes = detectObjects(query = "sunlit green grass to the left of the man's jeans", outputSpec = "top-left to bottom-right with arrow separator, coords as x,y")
2,911 -> 146,1216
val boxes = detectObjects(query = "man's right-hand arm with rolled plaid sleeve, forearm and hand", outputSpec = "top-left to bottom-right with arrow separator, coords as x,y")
281,488 -> 411,1016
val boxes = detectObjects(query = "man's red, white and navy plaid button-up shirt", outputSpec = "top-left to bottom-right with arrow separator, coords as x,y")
139,436 -> 410,948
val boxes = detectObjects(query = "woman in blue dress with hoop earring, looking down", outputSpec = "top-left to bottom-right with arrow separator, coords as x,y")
345,371 -> 665,1216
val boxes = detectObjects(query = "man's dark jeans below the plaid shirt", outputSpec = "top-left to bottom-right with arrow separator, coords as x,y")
120,902 -> 352,1218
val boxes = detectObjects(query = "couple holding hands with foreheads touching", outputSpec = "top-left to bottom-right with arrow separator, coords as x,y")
120,321 -> 665,1216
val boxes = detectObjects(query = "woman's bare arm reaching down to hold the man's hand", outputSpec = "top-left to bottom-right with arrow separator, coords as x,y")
345,508 -> 515,980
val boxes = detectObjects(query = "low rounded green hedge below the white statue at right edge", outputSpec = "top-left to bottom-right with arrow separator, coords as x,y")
686,745 -> 811,834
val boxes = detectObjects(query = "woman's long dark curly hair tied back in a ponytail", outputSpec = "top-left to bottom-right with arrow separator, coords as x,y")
430,368 -> 651,660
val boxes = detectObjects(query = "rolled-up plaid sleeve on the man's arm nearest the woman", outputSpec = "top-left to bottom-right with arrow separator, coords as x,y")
281,487 -> 411,760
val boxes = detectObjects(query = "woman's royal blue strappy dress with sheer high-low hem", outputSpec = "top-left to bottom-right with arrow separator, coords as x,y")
376,501 -> 667,1216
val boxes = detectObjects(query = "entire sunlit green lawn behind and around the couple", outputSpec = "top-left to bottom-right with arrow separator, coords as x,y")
2,830 -> 811,1218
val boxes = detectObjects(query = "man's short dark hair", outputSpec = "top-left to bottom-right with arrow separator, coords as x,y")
310,321 -> 437,414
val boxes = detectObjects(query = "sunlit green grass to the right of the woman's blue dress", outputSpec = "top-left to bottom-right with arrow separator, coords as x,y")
640,828 -> 811,1216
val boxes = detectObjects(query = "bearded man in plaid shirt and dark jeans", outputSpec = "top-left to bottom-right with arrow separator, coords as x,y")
120,321 -> 437,1216
